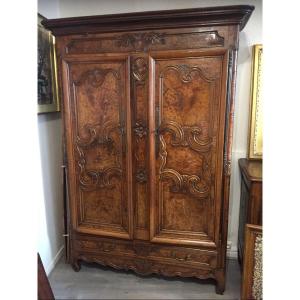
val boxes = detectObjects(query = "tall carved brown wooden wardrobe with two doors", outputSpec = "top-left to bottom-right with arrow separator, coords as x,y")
43,5 -> 254,293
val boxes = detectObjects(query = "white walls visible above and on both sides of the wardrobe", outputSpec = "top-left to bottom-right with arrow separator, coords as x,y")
38,0 -> 262,270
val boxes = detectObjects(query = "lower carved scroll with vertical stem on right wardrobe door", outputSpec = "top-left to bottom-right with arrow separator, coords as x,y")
159,135 -> 209,199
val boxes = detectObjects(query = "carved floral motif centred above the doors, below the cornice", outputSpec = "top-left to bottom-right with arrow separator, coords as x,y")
116,32 -> 165,51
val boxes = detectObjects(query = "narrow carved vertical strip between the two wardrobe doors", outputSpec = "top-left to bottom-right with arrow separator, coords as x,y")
131,53 -> 149,240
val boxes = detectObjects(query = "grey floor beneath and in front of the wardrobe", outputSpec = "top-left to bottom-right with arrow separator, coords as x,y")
49,255 -> 241,300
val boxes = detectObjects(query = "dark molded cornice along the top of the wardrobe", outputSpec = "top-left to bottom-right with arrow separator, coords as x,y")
42,5 -> 254,36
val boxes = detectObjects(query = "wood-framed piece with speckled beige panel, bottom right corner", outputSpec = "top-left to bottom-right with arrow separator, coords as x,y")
241,224 -> 263,300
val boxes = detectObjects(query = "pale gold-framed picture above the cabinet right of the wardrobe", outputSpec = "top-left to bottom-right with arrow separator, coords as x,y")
248,45 -> 263,159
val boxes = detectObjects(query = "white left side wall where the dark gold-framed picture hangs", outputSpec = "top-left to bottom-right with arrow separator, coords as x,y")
38,0 -> 64,274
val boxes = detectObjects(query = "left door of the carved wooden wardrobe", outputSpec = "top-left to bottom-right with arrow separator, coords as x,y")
62,55 -> 133,239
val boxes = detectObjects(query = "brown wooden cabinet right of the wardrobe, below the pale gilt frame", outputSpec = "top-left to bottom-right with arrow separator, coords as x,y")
238,158 -> 262,266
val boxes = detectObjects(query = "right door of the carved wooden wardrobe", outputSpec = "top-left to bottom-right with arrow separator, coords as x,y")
149,50 -> 227,248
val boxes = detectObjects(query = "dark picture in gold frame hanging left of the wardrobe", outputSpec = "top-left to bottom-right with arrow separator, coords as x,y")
38,14 -> 60,113
